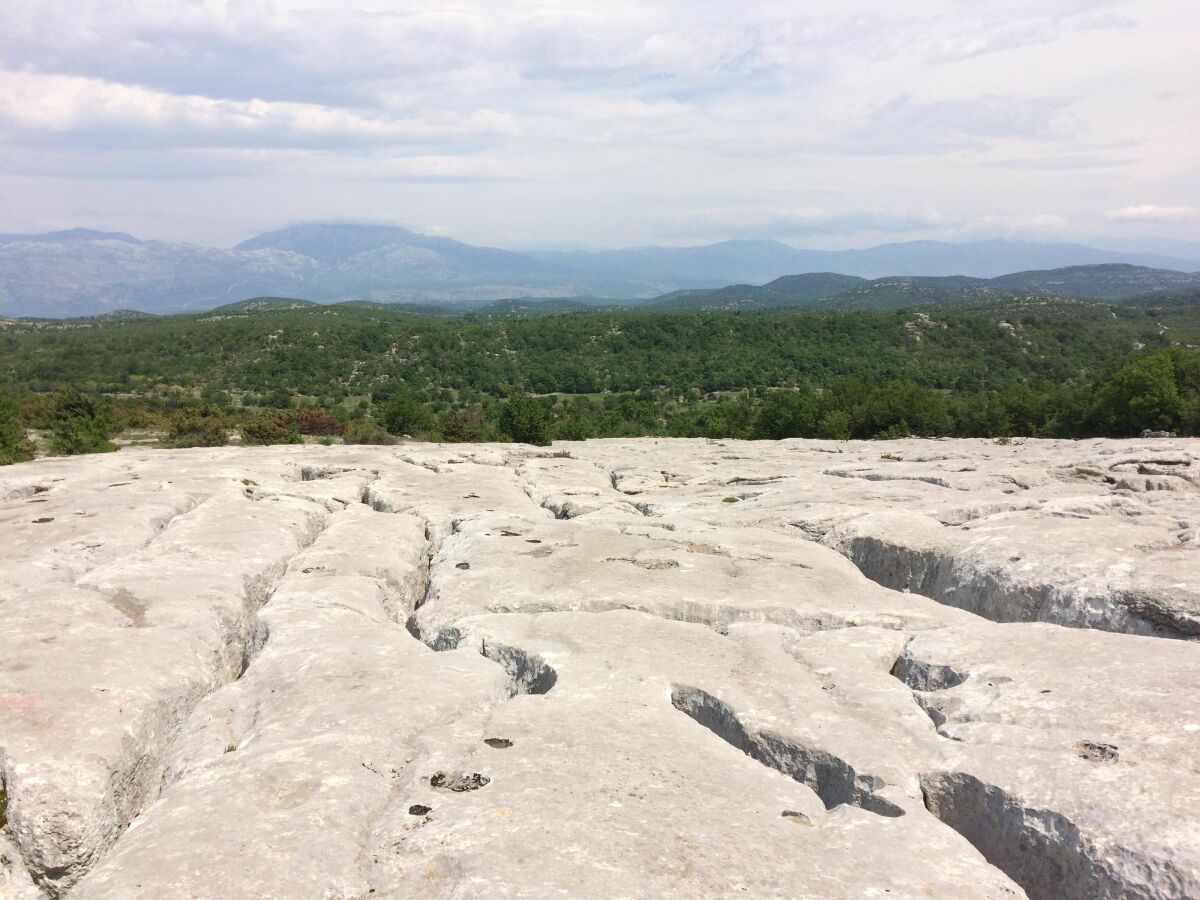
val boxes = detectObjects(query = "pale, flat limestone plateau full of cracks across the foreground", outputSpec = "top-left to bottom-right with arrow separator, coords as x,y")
0,439 -> 1200,900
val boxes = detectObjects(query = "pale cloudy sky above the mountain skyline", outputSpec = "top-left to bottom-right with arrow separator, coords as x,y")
0,0 -> 1200,254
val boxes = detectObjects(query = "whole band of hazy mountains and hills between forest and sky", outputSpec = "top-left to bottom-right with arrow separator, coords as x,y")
0,223 -> 1200,318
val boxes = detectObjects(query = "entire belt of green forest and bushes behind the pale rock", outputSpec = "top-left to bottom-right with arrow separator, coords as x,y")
0,293 -> 1200,462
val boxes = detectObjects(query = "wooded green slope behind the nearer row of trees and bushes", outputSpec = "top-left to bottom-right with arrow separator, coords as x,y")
0,293 -> 1200,403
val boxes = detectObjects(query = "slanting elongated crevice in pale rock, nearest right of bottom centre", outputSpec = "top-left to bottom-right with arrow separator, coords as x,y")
671,684 -> 905,818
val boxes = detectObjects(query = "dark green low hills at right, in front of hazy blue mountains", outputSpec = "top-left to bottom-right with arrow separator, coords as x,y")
642,264 -> 1200,312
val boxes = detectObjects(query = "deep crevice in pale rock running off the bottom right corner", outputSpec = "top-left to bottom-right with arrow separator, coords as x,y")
920,772 -> 1200,900
